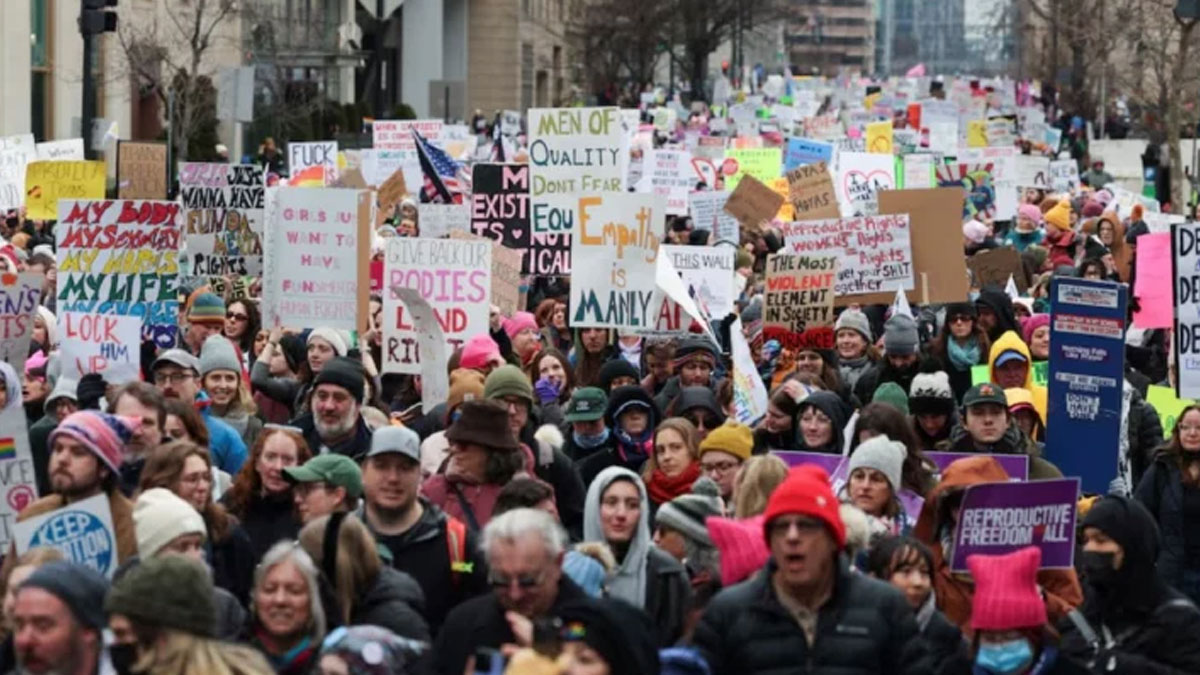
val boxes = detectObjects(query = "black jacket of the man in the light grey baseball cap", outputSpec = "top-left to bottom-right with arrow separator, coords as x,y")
358,497 -> 488,634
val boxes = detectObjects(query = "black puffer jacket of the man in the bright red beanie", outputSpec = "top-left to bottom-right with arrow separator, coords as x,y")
694,560 -> 925,675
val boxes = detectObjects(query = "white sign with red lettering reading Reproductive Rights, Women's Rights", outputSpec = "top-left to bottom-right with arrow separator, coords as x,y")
780,215 -> 913,297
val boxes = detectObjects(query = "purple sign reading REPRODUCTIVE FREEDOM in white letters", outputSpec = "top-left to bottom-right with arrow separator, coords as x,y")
950,478 -> 1079,572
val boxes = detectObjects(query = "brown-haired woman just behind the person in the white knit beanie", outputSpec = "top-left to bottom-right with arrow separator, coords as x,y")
138,441 -> 254,603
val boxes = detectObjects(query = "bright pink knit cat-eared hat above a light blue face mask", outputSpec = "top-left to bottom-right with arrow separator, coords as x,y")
967,546 -> 1046,631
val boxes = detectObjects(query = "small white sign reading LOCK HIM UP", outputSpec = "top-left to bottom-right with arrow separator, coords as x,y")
59,312 -> 142,384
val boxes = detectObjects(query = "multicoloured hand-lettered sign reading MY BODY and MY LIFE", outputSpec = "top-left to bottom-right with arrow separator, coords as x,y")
54,198 -> 182,347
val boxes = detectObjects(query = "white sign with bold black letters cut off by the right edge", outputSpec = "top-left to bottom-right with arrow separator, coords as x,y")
1171,222 -> 1200,399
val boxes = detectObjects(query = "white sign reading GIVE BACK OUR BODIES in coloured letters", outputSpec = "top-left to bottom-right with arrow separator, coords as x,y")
383,237 -> 493,374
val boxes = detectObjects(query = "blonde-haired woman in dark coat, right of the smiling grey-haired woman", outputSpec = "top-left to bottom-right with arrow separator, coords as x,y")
300,512 -> 430,641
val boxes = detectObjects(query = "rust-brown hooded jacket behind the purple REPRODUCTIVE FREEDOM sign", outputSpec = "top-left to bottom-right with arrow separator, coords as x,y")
913,456 -> 1084,639
